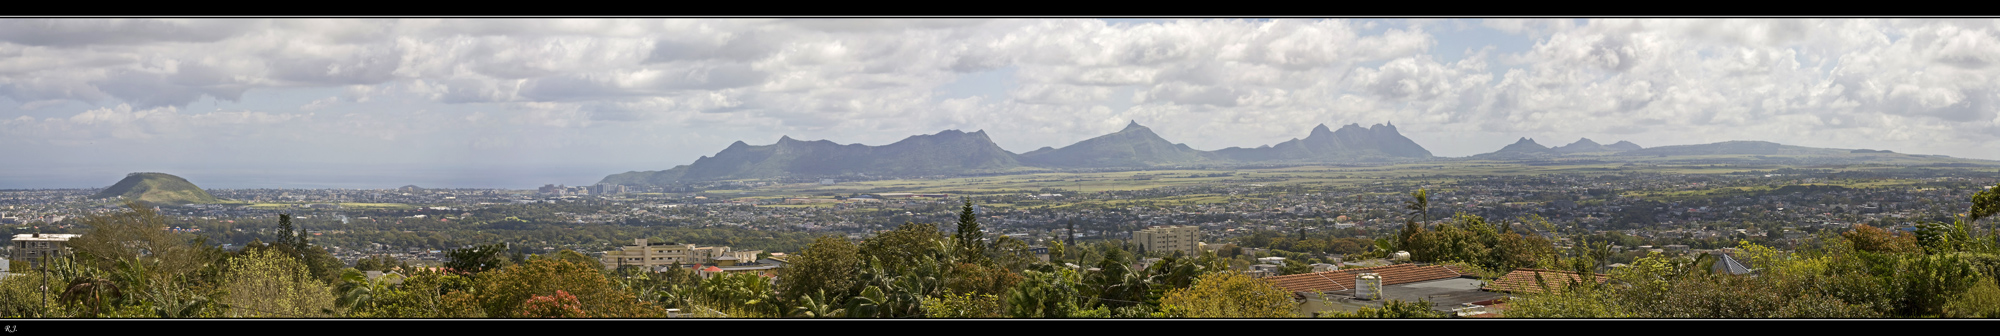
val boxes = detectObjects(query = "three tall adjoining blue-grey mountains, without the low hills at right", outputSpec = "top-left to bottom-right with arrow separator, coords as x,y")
600,122 -> 1432,186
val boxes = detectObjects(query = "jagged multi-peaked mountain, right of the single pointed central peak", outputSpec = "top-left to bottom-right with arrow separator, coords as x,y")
1214,124 -> 1432,162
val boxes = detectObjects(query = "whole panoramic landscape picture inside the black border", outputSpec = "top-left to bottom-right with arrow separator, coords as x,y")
0,18 -> 2000,320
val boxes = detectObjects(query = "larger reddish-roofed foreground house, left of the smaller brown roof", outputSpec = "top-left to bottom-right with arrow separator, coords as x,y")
1264,264 -> 1506,314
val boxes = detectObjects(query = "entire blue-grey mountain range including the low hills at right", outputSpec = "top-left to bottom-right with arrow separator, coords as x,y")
600,122 -> 1968,186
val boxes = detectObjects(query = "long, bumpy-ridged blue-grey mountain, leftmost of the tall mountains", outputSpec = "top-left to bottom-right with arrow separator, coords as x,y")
602,130 -> 1020,186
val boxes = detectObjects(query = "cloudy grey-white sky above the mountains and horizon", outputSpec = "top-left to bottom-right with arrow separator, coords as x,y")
0,18 -> 2000,188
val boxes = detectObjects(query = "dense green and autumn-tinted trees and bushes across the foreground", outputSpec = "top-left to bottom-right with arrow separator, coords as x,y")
0,182 -> 2000,318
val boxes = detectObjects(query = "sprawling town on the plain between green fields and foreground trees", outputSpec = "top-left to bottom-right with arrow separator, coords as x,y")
0,168 -> 1994,284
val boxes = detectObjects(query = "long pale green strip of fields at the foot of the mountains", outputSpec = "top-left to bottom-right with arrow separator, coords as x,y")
680,156 -> 2000,208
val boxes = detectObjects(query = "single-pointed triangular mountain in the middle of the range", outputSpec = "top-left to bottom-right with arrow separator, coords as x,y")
1020,122 -> 1218,168
